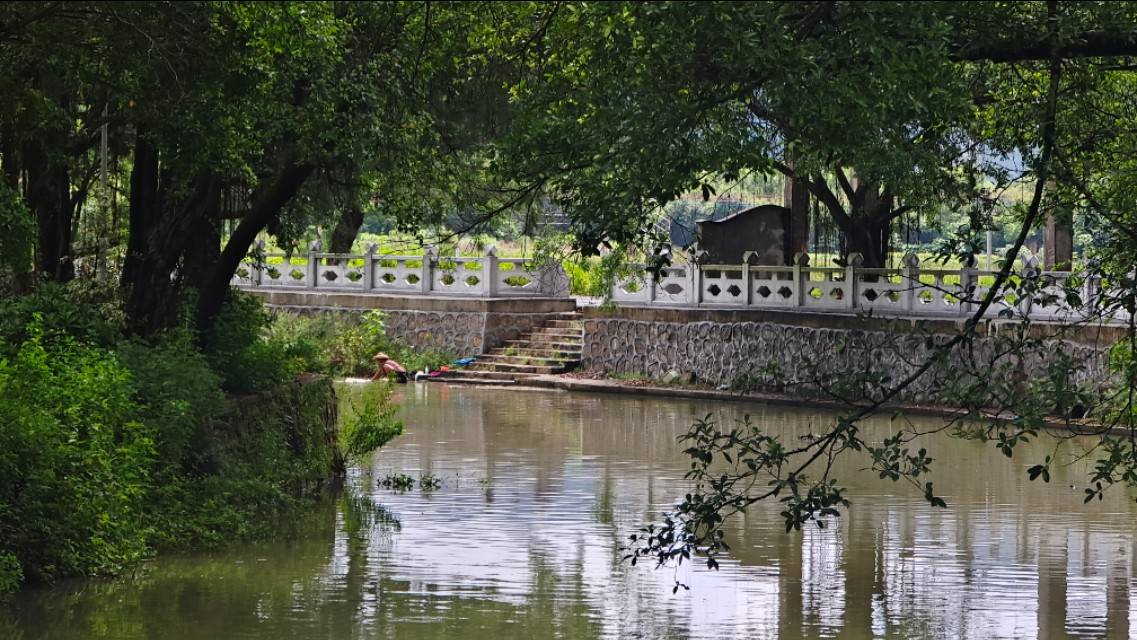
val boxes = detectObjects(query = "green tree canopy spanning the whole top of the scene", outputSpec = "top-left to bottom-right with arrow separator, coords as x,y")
0,1 -> 1137,325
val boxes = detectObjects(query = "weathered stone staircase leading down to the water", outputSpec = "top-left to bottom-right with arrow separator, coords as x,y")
435,313 -> 584,384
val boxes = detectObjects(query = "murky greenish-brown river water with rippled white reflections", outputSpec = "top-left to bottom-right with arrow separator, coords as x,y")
0,384 -> 1137,640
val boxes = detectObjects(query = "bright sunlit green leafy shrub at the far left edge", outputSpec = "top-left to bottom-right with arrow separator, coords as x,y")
0,323 -> 153,580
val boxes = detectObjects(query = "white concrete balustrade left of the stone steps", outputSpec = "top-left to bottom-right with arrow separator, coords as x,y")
232,242 -> 569,298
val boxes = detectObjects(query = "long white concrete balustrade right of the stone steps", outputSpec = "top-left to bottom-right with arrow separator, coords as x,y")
612,253 -> 1128,322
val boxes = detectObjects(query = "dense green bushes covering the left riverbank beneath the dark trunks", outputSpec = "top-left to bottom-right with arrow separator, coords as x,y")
0,283 -> 407,592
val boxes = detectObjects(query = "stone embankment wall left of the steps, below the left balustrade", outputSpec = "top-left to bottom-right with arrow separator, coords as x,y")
243,290 -> 576,356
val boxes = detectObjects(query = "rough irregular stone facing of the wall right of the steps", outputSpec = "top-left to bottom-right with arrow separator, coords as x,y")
582,311 -> 1107,401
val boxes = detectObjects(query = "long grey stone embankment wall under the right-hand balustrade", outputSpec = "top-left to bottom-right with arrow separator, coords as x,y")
582,307 -> 1119,401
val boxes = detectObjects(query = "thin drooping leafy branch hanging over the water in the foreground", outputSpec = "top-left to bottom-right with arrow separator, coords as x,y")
625,34 -> 1062,589
